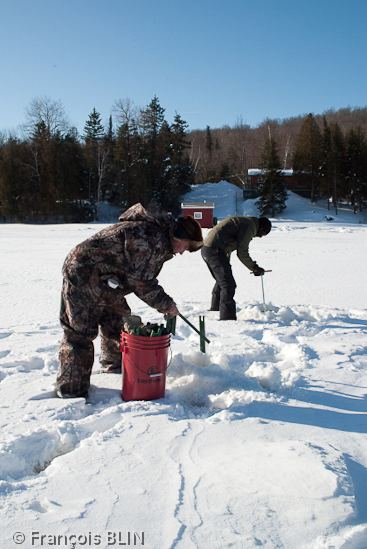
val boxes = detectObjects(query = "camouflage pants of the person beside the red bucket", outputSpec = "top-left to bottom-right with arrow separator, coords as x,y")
56,279 -> 131,396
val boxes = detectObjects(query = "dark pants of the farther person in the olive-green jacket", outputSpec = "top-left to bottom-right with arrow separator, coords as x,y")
201,246 -> 237,320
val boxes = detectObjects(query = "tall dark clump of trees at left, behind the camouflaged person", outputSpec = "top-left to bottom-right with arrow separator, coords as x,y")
0,97 -> 194,222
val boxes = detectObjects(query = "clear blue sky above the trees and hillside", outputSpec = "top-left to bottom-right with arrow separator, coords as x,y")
0,0 -> 367,133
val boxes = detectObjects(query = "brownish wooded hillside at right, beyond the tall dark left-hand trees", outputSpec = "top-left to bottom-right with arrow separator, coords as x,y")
189,108 -> 367,211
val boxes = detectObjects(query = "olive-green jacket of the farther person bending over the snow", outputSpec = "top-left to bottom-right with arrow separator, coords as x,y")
204,216 -> 259,271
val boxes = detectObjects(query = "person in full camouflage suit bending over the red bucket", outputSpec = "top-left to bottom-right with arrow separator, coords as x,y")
56,204 -> 203,398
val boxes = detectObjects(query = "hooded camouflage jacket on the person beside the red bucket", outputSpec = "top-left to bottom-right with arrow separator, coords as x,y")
62,204 -> 175,313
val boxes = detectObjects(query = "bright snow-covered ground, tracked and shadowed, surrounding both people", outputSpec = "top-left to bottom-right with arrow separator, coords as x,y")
0,183 -> 367,549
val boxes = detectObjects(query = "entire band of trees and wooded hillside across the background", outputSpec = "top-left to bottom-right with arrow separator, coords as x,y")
0,97 -> 367,222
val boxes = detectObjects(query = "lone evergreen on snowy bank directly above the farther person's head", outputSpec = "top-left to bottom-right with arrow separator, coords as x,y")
256,137 -> 288,217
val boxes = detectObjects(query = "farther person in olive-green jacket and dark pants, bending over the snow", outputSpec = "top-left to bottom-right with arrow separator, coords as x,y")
201,216 -> 271,320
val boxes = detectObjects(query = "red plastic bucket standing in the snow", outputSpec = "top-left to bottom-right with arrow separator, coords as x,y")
121,332 -> 171,401
